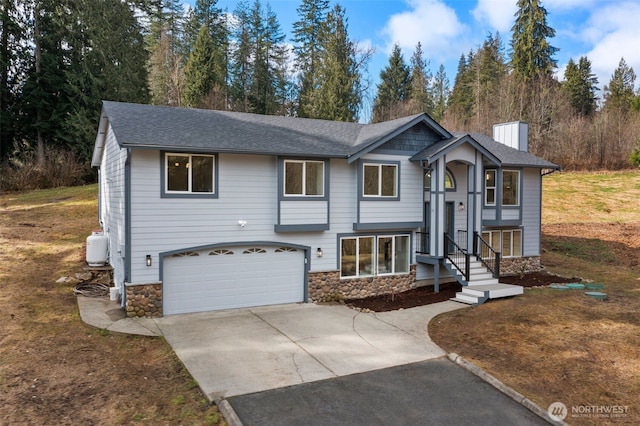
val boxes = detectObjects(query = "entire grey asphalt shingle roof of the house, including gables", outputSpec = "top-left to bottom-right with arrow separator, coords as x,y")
96,101 -> 558,168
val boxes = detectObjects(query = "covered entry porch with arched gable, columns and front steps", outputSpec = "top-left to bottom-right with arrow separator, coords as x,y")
412,135 -> 522,304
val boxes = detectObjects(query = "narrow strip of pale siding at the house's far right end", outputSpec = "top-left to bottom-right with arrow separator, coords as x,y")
522,169 -> 542,256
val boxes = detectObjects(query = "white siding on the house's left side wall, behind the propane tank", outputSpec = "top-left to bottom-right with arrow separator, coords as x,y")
99,126 -> 127,287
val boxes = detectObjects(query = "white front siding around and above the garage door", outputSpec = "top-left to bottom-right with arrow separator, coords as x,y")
131,150 -> 368,283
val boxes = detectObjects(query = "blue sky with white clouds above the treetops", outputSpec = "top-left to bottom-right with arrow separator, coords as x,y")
187,0 -> 640,113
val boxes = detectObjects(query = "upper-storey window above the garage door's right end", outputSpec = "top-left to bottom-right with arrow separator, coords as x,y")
284,160 -> 324,197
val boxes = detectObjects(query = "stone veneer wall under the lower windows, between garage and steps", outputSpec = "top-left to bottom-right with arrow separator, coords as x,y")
308,265 -> 416,302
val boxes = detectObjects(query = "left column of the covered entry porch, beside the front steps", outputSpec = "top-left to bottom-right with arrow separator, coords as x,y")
429,157 -> 446,257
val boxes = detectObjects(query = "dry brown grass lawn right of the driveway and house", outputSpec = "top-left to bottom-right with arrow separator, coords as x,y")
429,172 -> 640,425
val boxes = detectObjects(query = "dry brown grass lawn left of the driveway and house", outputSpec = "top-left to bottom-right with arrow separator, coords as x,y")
0,185 -> 224,425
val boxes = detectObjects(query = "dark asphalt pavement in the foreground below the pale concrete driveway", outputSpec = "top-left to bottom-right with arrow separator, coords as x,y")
228,358 -> 548,426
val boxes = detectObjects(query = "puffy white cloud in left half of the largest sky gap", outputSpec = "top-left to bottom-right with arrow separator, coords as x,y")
382,0 -> 468,63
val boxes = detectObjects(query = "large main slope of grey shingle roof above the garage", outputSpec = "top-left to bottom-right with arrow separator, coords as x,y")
104,102 -> 364,157
